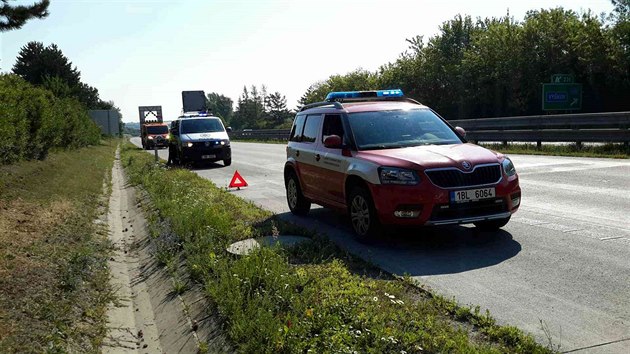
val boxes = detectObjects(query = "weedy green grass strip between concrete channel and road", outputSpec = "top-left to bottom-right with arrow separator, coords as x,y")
122,144 -> 551,353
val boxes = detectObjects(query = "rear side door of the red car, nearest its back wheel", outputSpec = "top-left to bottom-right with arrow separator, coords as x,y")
287,114 -> 322,197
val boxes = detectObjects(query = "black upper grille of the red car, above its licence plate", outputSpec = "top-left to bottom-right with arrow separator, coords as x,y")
425,164 -> 501,188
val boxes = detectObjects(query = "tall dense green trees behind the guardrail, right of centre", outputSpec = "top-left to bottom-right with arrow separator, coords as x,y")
299,0 -> 630,119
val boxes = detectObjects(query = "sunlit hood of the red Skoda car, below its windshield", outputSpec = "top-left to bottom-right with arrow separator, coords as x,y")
356,144 -> 503,170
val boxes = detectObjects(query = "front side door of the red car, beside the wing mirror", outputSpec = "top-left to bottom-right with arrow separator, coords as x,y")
315,114 -> 349,204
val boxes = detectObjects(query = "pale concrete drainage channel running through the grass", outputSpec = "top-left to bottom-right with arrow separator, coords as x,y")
102,151 -> 232,353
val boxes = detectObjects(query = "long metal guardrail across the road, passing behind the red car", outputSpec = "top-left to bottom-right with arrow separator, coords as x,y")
230,112 -> 630,146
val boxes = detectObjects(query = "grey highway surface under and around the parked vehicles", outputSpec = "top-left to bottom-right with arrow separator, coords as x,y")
132,138 -> 630,354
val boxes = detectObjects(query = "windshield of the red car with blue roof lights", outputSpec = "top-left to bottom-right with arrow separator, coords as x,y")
348,108 -> 462,150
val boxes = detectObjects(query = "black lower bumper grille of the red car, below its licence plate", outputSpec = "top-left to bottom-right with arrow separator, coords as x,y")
431,198 -> 507,221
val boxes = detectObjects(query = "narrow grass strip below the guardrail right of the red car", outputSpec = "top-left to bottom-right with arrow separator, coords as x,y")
479,143 -> 630,159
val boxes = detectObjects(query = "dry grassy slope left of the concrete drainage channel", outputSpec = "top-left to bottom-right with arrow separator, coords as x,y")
0,141 -> 115,353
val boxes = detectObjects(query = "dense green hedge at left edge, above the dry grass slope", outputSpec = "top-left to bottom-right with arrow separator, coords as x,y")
0,75 -> 100,165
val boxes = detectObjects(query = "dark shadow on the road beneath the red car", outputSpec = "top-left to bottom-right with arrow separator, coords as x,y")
279,208 -> 521,276
